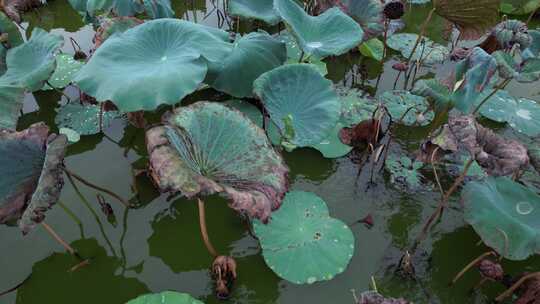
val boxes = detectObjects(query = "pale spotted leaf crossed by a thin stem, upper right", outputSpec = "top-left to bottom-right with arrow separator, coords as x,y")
386,33 -> 450,65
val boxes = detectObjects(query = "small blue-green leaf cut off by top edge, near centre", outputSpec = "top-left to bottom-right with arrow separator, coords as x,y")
229,0 -> 281,25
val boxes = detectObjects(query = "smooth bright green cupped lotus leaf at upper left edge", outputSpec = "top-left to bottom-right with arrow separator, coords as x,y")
2,28 -> 64,91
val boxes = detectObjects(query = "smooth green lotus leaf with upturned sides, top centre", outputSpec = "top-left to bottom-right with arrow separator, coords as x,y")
274,0 -> 364,58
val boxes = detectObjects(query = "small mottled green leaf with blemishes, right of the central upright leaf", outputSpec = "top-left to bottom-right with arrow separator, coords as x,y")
379,90 -> 435,126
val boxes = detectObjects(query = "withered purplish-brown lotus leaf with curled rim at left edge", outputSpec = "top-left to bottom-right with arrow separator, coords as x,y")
0,123 -> 67,233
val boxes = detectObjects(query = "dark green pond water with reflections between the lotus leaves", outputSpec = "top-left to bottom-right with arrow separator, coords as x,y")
0,0 -> 540,304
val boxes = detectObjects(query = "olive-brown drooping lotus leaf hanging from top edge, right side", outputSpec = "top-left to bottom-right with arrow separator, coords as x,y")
433,0 -> 501,39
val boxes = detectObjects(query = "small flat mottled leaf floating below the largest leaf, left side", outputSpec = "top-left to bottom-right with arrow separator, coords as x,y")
54,101 -> 120,135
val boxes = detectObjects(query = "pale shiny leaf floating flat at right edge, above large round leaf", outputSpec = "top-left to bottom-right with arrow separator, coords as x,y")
480,91 -> 540,136
